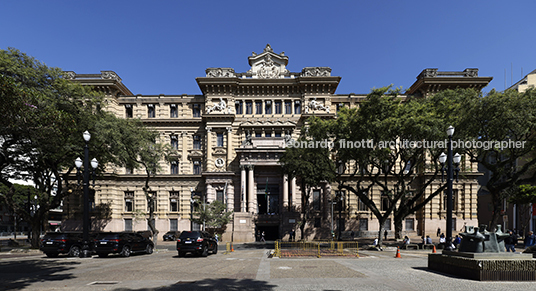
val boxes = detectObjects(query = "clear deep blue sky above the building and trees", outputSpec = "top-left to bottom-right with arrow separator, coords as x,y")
0,0 -> 536,95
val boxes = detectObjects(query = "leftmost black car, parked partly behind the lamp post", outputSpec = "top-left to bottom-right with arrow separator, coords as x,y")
39,232 -> 95,258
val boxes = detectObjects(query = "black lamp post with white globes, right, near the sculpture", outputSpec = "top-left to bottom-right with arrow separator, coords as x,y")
439,126 -> 461,251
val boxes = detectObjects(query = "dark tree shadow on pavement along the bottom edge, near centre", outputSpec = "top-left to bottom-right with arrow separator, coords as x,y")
114,278 -> 277,291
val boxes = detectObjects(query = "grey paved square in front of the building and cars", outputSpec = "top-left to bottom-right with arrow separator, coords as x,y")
0,242 -> 536,291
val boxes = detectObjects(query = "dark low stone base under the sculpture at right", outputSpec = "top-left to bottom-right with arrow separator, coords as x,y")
428,251 -> 536,281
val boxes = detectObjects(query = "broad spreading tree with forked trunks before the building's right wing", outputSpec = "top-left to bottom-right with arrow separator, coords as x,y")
309,87 -> 444,245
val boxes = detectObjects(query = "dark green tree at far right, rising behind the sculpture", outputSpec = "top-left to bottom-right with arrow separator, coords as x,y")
432,89 -> 536,229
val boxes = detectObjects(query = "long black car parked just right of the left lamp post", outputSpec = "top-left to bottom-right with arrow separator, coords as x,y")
94,232 -> 154,258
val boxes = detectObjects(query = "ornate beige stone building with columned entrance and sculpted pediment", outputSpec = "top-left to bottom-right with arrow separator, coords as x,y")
62,45 -> 491,242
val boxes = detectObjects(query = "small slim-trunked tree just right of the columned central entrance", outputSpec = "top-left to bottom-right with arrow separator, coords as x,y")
279,134 -> 335,240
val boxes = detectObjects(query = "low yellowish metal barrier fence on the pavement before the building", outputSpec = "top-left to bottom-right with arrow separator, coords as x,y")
274,240 -> 359,258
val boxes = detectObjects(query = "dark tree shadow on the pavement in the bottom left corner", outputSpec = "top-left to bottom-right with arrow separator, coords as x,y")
0,259 -> 80,290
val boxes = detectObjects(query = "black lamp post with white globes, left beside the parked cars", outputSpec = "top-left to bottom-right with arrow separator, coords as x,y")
74,130 -> 99,258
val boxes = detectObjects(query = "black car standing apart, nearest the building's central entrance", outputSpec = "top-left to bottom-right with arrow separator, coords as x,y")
177,231 -> 218,257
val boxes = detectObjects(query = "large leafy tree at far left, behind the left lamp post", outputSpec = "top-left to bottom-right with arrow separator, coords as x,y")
0,48 -> 157,247
